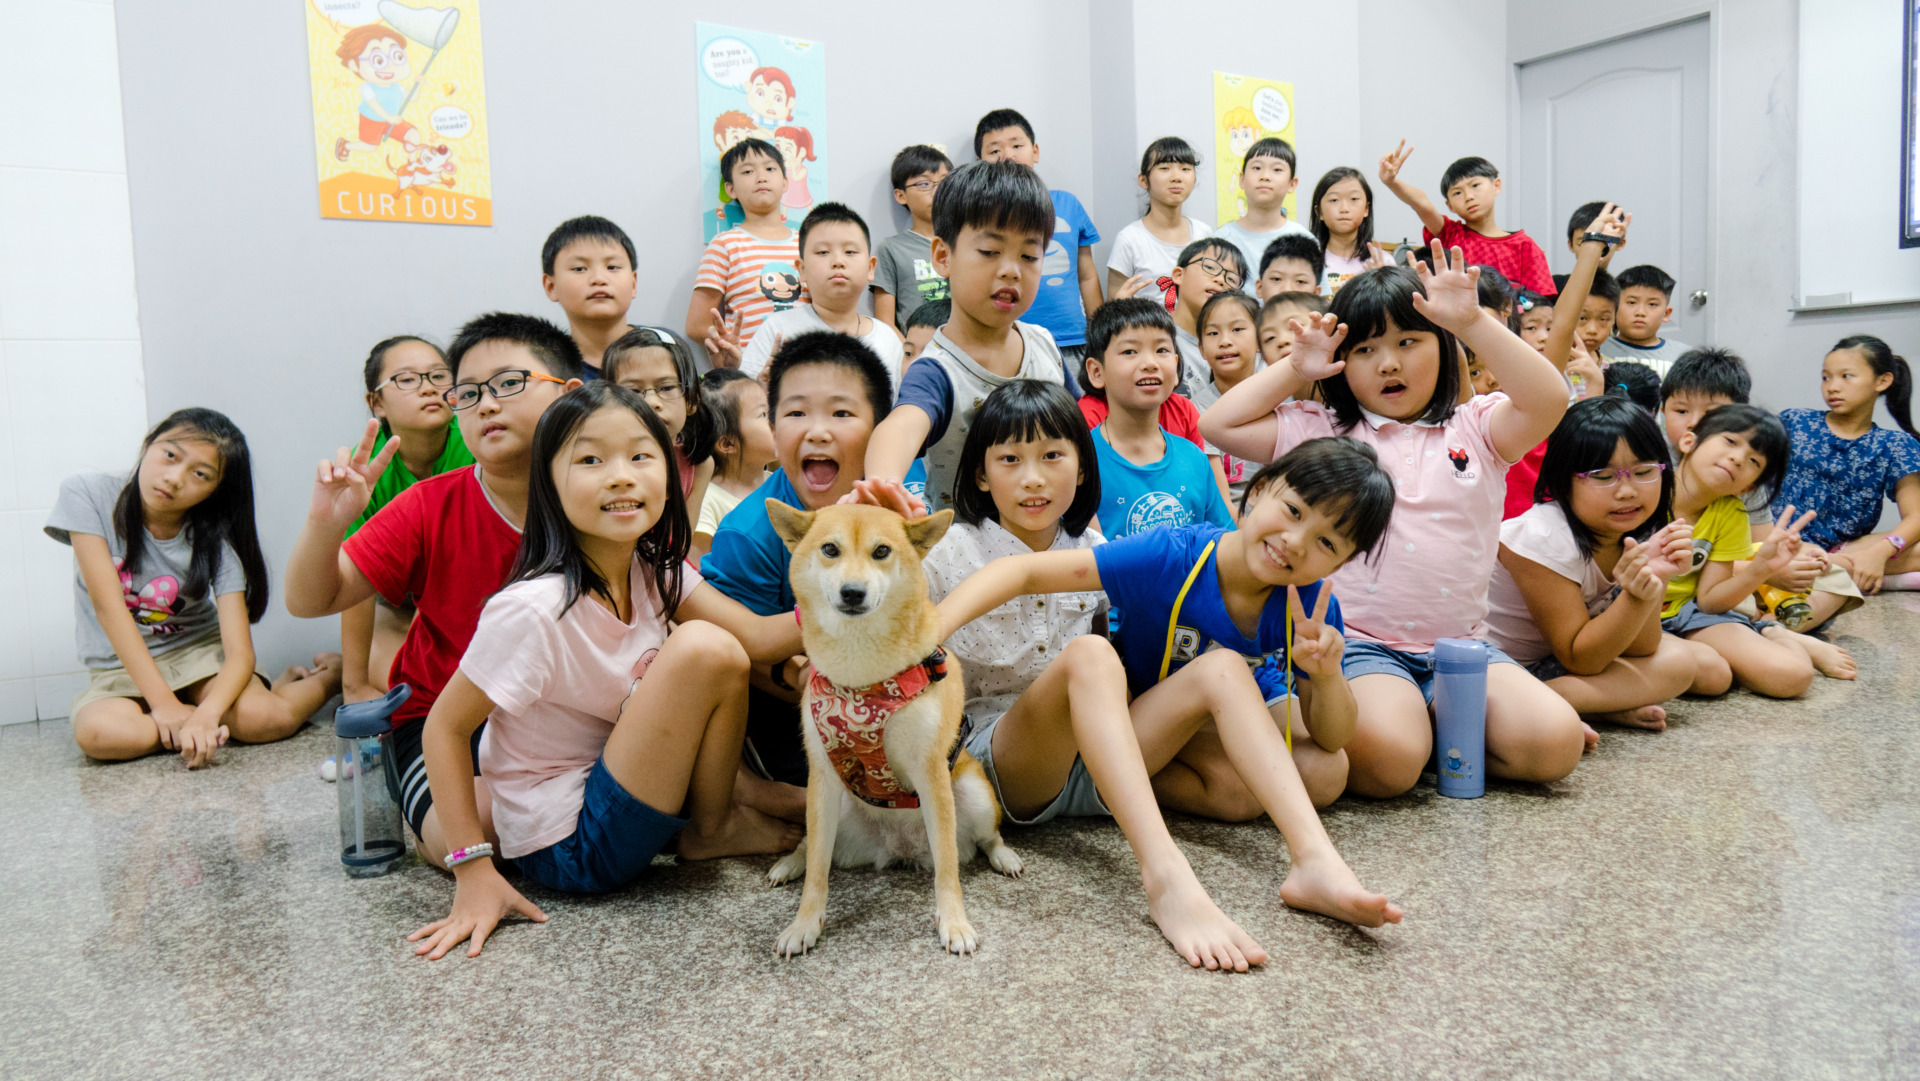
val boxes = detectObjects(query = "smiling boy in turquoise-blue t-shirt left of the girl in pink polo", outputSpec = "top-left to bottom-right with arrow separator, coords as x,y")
1081,298 -> 1233,537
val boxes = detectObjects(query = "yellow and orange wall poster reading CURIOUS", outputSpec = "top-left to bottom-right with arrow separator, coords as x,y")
301,0 -> 493,225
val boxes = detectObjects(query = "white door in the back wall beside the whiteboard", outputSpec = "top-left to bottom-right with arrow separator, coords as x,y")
1509,17 -> 1712,346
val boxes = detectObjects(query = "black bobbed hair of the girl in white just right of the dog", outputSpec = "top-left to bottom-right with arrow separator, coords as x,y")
954,378 -> 1100,538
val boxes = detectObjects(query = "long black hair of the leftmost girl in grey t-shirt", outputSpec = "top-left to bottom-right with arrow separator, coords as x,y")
113,409 -> 267,624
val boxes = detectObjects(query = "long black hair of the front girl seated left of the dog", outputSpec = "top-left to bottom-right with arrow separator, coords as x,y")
507,380 -> 693,620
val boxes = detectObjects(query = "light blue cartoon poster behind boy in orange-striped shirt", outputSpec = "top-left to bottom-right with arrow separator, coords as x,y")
693,23 -> 828,240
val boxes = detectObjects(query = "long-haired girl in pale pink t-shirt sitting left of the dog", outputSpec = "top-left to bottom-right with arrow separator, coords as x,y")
409,382 -> 801,958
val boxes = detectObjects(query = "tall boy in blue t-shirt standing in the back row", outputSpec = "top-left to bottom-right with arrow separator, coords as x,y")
973,109 -> 1100,367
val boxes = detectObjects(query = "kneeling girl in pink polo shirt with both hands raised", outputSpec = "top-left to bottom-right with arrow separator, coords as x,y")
1200,242 -> 1592,797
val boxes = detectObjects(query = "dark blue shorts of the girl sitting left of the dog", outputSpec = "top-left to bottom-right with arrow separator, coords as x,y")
513,758 -> 687,893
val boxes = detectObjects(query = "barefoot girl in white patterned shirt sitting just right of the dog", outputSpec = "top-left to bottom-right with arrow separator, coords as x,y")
922,380 -> 1267,972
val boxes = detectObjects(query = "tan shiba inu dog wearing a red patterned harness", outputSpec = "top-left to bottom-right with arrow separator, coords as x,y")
766,499 -> 1021,956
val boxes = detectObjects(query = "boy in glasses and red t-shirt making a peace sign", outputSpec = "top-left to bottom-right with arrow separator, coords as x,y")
286,313 -> 582,866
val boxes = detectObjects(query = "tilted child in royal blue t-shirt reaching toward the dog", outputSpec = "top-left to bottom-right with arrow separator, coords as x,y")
941,440 -> 1402,927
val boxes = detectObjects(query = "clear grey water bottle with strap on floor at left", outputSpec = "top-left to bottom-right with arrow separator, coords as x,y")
334,684 -> 413,877
